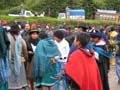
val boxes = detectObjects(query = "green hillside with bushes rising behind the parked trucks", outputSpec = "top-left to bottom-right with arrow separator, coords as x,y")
0,0 -> 120,19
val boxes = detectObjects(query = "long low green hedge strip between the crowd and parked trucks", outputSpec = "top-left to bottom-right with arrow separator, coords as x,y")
0,16 -> 119,27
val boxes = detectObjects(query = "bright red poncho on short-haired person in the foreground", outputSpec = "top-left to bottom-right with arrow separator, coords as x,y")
65,49 -> 102,90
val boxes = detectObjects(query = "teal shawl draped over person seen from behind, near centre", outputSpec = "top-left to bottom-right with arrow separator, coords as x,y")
33,38 -> 60,80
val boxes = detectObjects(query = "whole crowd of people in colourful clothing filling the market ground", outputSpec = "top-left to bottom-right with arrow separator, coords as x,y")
0,19 -> 120,90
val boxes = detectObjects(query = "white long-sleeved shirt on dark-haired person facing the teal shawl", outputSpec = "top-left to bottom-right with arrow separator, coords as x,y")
55,39 -> 70,62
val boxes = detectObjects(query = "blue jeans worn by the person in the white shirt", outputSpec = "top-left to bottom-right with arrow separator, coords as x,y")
56,62 -> 67,90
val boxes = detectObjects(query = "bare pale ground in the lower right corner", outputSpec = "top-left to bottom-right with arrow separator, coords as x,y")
109,66 -> 120,90
